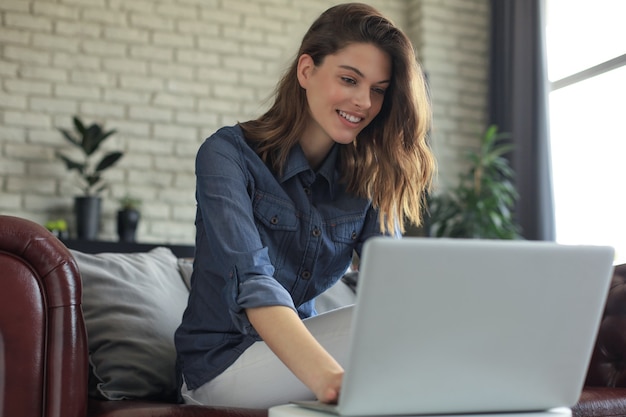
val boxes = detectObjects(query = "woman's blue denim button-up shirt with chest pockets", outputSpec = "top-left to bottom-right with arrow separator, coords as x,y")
175,126 -> 380,389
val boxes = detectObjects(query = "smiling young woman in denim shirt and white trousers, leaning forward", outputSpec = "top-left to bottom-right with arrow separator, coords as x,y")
175,3 -> 435,408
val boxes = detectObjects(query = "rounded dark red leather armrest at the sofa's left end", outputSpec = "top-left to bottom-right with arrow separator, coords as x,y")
0,215 -> 88,417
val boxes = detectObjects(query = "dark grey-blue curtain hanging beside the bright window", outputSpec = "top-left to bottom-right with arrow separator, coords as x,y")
489,0 -> 555,240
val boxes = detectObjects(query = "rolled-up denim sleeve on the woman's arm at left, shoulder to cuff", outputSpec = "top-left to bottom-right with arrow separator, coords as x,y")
194,130 -> 295,336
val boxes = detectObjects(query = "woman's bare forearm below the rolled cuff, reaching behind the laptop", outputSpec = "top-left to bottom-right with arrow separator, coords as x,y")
246,306 -> 343,403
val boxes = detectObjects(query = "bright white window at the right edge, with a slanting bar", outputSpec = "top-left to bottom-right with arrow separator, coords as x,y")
546,0 -> 626,263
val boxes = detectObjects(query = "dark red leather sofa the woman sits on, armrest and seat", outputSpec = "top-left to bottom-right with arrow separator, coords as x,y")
0,215 -> 626,417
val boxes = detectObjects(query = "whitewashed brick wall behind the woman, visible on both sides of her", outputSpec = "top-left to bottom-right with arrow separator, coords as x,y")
0,0 -> 489,243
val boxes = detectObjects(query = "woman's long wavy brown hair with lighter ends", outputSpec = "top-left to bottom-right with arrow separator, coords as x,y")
240,3 -> 436,232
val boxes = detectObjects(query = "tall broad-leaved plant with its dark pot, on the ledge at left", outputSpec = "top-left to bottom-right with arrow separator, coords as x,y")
56,116 -> 123,240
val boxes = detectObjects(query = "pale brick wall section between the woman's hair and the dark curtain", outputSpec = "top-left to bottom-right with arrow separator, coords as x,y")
411,0 -> 490,188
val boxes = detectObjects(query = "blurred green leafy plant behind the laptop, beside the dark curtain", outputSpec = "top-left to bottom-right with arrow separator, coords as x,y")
429,125 -> 521,239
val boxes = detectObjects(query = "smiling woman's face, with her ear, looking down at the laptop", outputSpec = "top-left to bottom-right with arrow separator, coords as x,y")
298,43 -> 391,155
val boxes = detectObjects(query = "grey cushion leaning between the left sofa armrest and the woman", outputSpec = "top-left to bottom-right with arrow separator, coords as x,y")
72,248 -> 188,400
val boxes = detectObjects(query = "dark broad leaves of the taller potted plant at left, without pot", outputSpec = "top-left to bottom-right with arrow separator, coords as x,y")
56,116 -> 123,196
